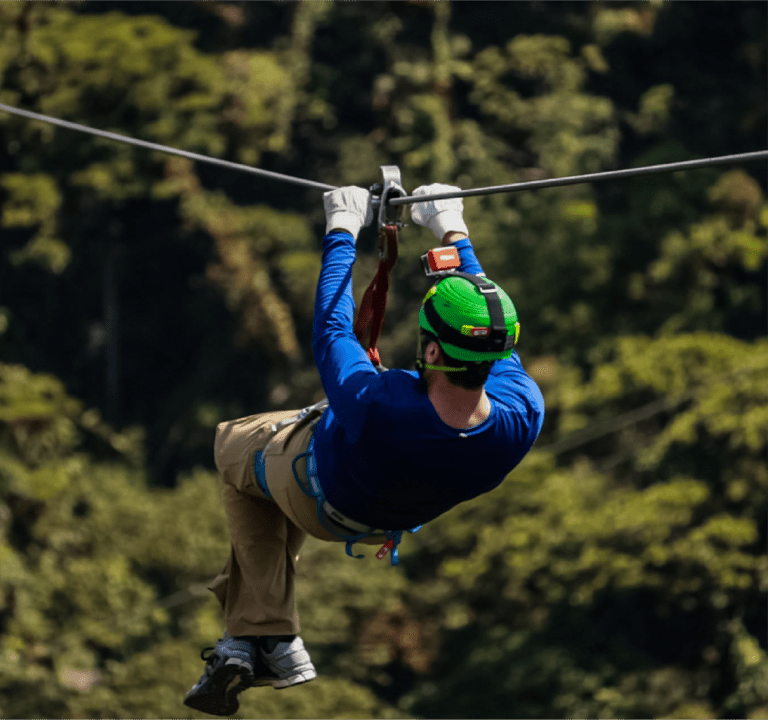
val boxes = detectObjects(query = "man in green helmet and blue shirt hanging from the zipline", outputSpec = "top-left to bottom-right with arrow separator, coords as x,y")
184,185 -> 544,715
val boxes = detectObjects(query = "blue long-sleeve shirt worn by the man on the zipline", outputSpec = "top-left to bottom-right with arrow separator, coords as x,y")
312,232 -> 544,530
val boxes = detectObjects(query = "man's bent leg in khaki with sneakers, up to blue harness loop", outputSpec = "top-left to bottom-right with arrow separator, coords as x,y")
184,412 -> 316,715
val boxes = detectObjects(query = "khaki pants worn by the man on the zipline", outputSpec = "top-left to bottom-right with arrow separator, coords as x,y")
209,410 -> 386,637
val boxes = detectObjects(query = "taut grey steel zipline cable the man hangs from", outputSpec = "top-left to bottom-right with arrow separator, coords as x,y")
0,103 -> 768,200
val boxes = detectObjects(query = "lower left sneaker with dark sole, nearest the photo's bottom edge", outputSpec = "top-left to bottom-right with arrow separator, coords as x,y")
184,633 -> 268,716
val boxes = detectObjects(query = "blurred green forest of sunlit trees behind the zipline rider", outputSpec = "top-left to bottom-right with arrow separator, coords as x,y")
0,0 -> 768,718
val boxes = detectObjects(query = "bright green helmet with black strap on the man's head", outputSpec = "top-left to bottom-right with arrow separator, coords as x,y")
419,273 -> 520,362
